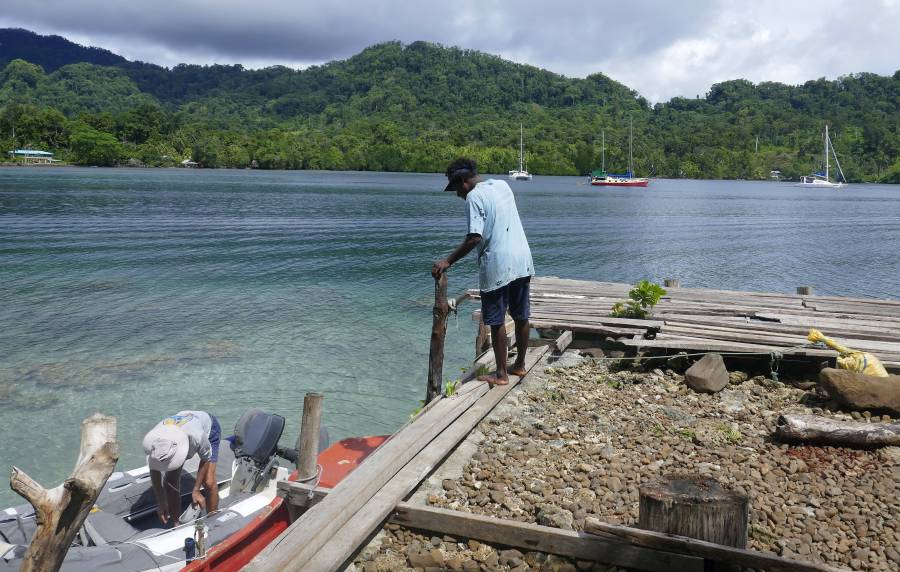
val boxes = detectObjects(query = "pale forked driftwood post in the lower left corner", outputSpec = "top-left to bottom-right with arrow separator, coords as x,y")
9,413 -> 119,572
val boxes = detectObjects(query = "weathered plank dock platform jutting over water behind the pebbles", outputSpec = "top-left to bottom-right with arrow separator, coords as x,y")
531,278 -> 900,372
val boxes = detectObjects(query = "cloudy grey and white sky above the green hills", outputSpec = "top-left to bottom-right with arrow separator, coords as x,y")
0,0 -> 900,102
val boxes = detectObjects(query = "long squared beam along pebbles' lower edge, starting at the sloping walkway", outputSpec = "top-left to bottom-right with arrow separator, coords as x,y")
391,503 -> 703,572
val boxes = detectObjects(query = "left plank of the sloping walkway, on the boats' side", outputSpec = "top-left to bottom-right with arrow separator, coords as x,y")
245,387 -> 487,571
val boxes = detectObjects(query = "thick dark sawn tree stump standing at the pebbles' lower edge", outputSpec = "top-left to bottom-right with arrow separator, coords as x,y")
638,476 -> 749,548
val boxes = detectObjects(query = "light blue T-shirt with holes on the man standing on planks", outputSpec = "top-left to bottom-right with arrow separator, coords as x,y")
466,179 -> 534,292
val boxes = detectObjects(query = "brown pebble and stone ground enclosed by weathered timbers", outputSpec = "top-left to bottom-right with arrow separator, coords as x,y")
356,352 -> 900,572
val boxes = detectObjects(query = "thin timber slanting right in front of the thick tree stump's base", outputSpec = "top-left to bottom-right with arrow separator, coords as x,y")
584,518 -> 844,572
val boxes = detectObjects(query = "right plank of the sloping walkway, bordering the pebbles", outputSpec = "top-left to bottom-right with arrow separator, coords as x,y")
288,346 -> 549,572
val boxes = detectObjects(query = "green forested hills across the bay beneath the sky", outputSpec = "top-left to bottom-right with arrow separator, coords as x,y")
0,30 -> 900,182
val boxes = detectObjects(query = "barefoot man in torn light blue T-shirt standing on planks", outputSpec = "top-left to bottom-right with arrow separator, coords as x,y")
431,157 -> 534,385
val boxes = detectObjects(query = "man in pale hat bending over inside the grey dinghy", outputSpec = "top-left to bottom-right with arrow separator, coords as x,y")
143,411 -> 222,527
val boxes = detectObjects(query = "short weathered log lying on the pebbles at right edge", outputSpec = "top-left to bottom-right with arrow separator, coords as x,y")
775,415 -> 900,448
